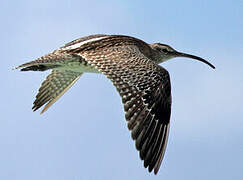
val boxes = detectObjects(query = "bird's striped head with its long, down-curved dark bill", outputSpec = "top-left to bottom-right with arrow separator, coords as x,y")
150,43 -> 215,69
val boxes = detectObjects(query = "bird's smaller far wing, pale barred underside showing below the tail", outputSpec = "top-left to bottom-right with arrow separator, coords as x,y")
32,70 -> 82,113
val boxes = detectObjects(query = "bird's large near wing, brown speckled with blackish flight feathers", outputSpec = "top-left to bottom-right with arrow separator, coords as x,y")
75,45 -> 171,174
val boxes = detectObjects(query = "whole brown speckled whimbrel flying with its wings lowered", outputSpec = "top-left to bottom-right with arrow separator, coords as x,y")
16,34 -> 215,174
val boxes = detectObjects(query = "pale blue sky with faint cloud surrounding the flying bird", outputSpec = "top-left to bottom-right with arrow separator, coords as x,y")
0,0 -> 243,180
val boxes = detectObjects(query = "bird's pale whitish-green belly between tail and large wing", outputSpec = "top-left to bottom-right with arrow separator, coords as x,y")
55,62 -> 100,73
